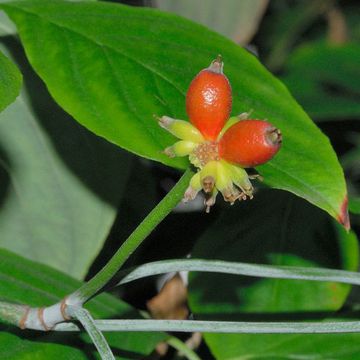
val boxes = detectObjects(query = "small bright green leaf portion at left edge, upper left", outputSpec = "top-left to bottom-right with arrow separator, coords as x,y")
0,48 -> 22,111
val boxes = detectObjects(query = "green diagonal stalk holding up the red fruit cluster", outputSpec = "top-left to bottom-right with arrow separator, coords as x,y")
67,169 -> 194,304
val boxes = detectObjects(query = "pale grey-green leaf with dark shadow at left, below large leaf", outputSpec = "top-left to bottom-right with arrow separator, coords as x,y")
0,40 -> 131,278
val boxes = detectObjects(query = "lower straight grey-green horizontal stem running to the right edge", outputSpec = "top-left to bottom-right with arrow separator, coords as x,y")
54,320 -> 360,334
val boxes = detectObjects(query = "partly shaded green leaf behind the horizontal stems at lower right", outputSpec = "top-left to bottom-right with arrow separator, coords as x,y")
189,190 -> 358,359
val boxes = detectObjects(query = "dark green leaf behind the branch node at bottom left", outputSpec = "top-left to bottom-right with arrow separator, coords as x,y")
0,250 -> 166,360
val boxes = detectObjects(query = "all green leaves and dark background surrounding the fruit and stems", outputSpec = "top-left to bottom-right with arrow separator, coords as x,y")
0,0 -> 360,359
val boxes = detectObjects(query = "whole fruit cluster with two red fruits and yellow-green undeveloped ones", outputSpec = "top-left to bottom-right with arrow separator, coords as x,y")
159,56 -> 281,212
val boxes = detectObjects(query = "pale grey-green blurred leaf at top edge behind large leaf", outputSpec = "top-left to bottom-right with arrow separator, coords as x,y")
155,0 -> 268,45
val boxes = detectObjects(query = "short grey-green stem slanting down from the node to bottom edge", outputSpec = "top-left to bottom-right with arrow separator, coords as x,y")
69,306 -> 115,360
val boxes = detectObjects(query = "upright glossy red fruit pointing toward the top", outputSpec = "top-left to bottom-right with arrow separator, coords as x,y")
186,57 -> 232,140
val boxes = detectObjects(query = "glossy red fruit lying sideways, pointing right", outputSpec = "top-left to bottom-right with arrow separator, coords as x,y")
219,120 -> 281,167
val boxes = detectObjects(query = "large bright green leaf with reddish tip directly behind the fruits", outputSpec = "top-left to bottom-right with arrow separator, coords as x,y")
1,0 -> 347,223
